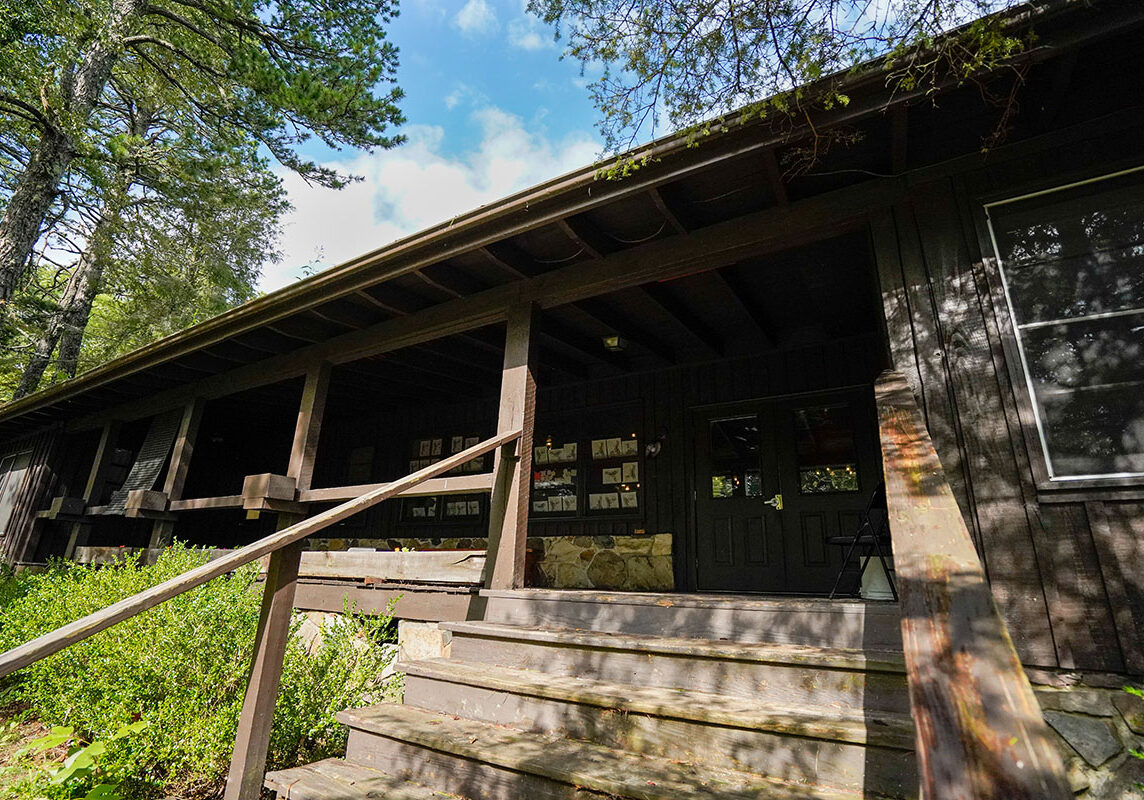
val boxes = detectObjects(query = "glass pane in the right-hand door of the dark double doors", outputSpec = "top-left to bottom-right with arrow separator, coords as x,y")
794,405 -> 858,494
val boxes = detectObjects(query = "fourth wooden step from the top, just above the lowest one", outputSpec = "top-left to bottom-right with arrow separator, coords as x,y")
337,705 -> 861,800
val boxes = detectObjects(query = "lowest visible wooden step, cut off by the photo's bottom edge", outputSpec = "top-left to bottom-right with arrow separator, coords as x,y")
264,759 -> 462,800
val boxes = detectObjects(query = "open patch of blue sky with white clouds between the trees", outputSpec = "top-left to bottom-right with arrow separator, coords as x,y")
262,0 -> 601,291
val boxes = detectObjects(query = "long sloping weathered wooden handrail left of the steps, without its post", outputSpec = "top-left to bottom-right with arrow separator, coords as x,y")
0,430 -> 521,678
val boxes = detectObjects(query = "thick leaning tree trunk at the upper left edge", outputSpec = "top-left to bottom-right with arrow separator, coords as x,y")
0,0 -> 144,304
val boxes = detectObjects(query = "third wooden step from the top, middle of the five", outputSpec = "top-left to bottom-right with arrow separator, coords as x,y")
398,659 -> 916,797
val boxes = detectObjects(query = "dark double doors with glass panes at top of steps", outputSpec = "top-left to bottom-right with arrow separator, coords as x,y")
696,389 -> 881,594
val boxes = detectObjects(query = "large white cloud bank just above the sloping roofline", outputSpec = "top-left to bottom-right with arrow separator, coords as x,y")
262,106 -> 599,291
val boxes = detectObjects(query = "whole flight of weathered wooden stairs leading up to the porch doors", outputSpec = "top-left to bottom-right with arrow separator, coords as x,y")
265,589 -> 917,800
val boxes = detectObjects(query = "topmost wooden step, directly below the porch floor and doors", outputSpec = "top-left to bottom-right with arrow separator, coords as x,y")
480,589 -> 901,651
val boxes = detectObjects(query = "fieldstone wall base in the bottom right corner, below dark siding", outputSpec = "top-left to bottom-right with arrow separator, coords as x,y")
1034,686 -> 1144,800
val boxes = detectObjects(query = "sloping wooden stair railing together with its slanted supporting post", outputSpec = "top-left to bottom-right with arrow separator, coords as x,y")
0,429 -> 521,800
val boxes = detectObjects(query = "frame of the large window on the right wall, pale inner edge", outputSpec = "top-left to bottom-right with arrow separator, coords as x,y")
975,161 -> 1144,493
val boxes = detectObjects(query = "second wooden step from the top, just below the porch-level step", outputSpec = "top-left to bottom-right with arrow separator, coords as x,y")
440,623 -> 909,713
